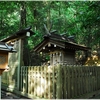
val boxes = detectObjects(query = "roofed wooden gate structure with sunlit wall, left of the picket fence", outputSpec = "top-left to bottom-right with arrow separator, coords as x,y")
0,27 -> 35,89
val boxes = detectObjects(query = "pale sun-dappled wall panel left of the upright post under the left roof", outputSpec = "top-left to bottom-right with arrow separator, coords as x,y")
2,41 -> 19,88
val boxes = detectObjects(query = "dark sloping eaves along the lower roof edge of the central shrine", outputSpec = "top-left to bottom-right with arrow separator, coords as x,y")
34,38 -> 91,52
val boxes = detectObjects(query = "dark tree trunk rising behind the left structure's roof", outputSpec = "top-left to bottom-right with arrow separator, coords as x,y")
20,1 -> 30,66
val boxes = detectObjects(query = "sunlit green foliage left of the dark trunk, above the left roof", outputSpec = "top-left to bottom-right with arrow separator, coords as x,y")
0,1 -> 19,38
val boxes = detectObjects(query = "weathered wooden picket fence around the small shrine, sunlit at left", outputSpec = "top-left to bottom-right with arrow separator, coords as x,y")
1,65 -> 100,99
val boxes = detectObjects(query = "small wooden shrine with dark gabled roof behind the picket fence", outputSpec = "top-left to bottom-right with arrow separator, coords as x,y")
34,32 -> 90,65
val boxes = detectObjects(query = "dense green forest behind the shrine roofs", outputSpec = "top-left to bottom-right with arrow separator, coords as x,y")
0,1 -> 100,65
